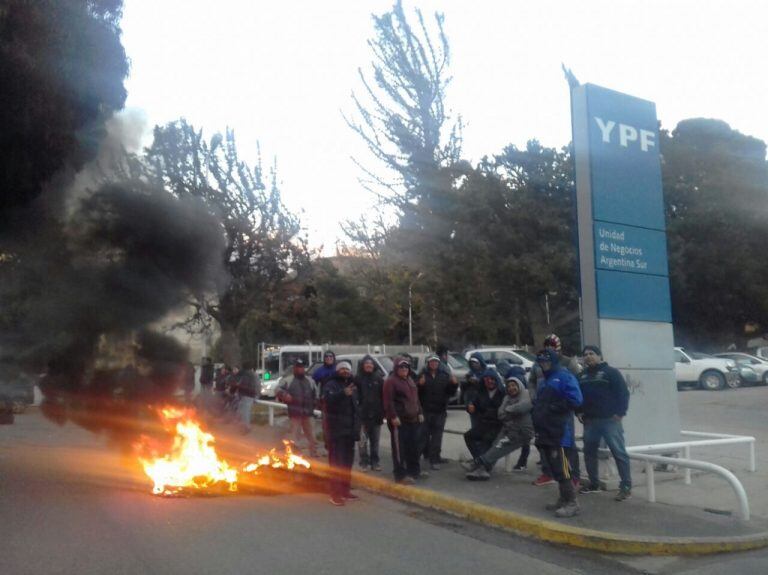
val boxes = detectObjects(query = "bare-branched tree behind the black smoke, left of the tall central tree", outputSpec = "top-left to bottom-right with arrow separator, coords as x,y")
120,119 -> 310,364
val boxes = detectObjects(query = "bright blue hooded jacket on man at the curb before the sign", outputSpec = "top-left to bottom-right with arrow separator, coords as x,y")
533,350 -> 583,447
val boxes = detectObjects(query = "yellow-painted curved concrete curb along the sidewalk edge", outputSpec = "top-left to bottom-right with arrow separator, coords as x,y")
352,472 -> 768,555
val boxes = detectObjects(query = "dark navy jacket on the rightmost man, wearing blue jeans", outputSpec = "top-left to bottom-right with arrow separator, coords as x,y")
577,362 -> 629,419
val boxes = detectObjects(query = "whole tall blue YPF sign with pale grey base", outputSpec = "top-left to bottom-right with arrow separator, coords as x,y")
571,84 -> 680,445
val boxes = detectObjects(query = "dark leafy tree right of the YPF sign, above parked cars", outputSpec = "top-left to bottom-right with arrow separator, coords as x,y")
660,118 -> 768,348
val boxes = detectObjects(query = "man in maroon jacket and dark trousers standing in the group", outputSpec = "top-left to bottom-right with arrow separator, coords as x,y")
384,358 -> 424,484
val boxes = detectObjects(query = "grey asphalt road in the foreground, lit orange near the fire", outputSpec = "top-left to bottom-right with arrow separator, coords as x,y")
0,388 -> 768,575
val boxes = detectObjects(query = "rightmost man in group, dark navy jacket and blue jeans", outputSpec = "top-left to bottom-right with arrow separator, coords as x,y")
577,345 -> 632,501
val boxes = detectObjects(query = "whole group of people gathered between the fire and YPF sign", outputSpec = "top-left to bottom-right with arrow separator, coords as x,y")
195,334 -> 632,517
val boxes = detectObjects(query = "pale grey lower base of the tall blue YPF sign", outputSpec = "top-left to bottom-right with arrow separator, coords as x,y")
599,319 -> 680,445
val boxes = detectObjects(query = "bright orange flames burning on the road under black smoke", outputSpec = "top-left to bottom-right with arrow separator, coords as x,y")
139,407 -> 311,495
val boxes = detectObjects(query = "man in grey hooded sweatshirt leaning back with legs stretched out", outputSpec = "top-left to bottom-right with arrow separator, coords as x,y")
463,371 -> 533,481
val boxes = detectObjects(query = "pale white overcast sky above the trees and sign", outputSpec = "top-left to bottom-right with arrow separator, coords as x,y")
122,0 -> 768,254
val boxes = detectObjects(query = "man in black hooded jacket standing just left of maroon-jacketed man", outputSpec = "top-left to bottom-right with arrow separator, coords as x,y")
355,355 -> 384,471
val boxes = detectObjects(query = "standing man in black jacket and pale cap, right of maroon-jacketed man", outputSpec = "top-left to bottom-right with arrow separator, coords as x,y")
419,354 -> 459,470
